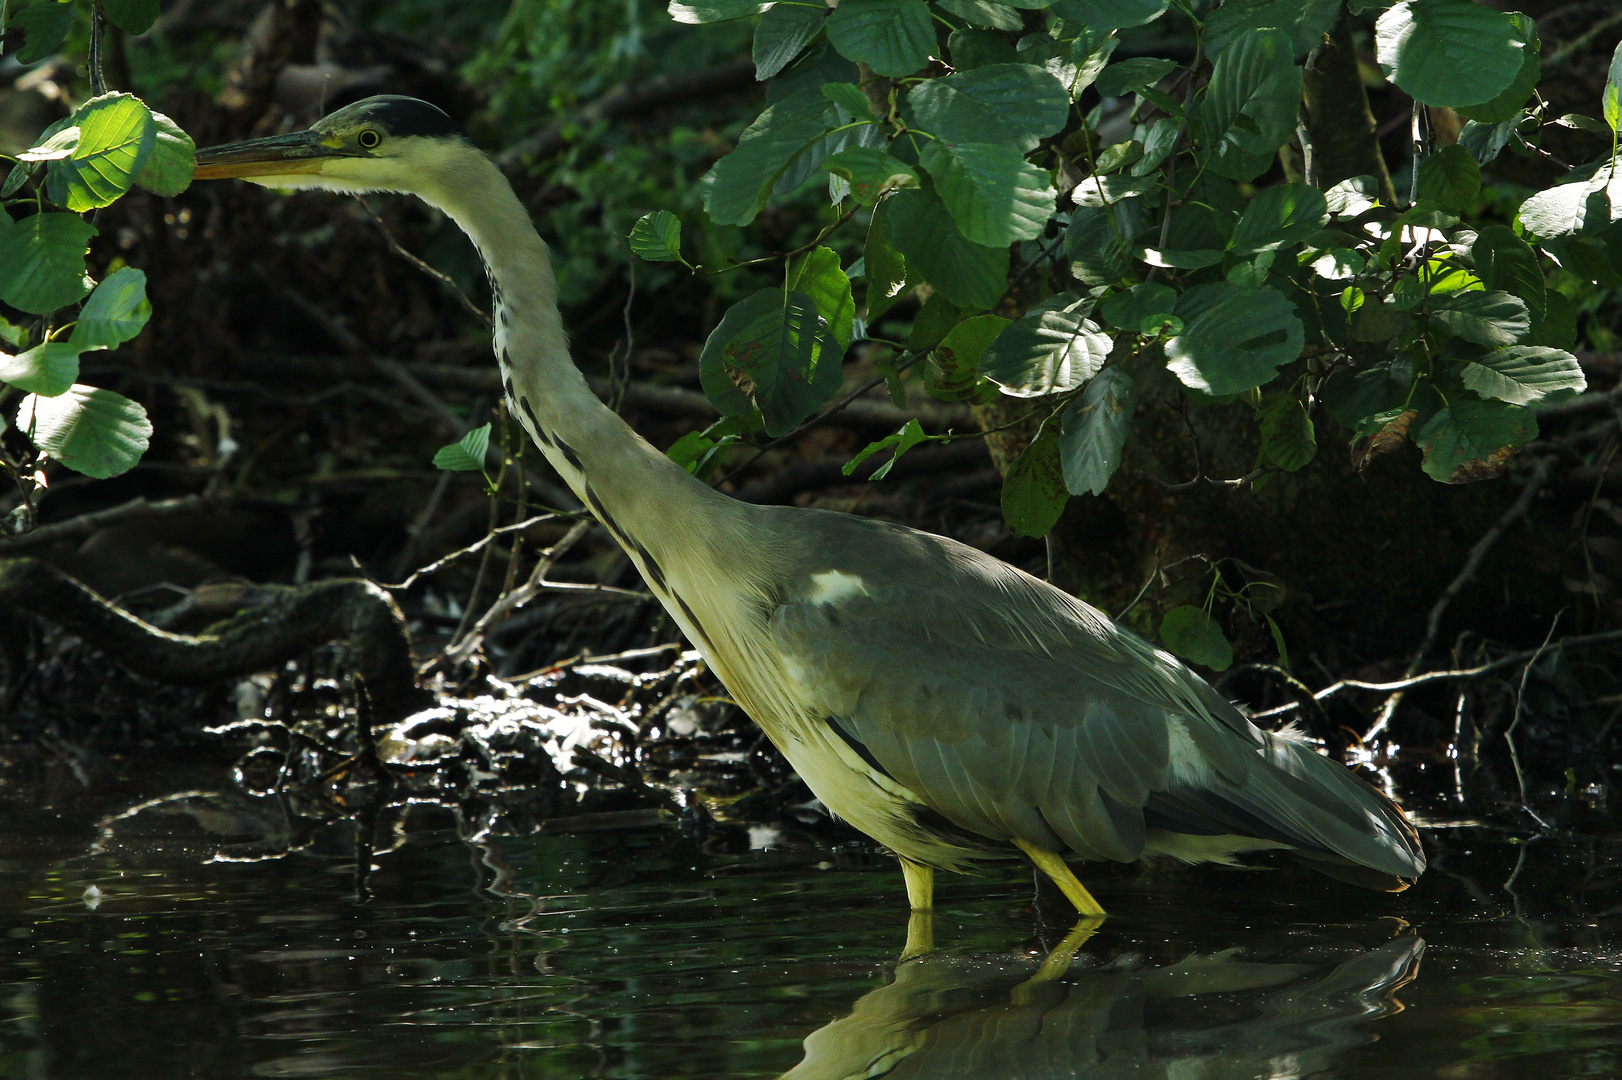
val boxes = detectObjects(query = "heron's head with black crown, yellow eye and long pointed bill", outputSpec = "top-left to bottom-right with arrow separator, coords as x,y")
196,94 -> 473,196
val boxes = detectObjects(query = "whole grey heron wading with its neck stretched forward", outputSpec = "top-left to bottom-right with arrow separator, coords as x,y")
196,96 -> 1426,916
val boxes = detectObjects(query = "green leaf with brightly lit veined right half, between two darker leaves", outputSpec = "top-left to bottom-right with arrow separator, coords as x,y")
918,141 -> 1058,246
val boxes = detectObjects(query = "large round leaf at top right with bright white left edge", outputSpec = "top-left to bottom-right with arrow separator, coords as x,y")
1374,0 -> 1526,107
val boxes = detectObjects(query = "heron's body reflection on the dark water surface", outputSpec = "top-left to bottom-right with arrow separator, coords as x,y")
779,936 -> 1424,1080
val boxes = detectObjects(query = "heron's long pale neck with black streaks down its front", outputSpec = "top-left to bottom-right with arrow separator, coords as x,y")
427,156 -> 741,570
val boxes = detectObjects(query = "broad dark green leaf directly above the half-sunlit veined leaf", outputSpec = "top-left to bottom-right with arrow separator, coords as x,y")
907,63 -> 1071,154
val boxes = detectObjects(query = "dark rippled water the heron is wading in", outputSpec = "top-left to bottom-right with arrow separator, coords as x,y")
0,768 -> 1622,1080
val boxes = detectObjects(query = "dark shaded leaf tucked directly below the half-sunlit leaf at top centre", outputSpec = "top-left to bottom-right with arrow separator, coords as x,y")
882,186 -> 1009,308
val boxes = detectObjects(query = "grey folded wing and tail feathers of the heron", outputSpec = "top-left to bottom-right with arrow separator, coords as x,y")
770,519 -> 1424,877
